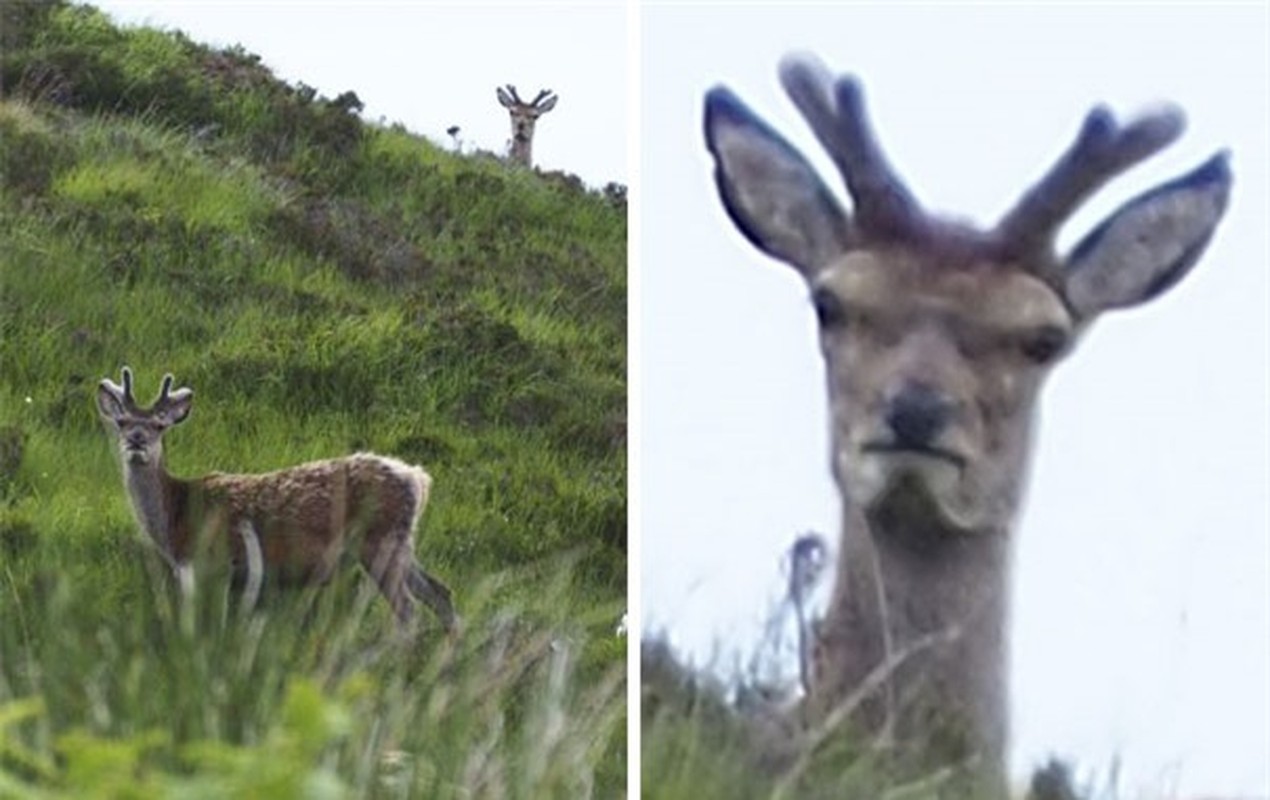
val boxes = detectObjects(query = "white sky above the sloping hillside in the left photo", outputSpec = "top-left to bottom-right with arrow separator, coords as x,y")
91,0 -> 626,187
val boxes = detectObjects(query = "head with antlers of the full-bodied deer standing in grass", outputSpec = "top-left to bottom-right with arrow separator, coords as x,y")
97,367 -> 194,465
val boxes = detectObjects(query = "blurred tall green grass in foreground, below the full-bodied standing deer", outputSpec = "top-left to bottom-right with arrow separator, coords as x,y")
0,559 -> 625,797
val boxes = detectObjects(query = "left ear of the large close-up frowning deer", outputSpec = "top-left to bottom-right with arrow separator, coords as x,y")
705,88 -> 848,279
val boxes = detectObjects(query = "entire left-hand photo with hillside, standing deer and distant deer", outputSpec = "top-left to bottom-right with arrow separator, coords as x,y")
0,0 -> 631,799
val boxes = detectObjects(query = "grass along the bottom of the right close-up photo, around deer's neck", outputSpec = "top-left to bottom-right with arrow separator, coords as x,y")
640,637 -> 1117,800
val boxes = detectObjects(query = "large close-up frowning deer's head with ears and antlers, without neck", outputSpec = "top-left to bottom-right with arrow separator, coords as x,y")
705,53 -> 1231,531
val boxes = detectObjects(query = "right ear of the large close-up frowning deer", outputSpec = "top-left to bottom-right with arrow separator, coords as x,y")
1066,152 -> 1231,317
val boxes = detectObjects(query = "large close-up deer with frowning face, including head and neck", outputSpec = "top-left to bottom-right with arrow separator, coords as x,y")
704,55 -> 1232,797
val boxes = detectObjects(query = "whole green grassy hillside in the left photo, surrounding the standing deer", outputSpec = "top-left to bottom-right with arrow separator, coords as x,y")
0,1 -> 626,797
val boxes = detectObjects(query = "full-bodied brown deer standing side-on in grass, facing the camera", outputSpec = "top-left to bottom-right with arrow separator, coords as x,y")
97,367 -> 458,632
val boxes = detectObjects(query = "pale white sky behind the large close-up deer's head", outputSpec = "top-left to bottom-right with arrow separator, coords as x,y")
645,4 -> 1270,797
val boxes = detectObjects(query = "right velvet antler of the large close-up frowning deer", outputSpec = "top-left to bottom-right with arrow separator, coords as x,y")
996,105 -> 1186,257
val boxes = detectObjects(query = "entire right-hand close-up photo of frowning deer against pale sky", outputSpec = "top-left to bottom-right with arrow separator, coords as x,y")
636,4 -> 1270,797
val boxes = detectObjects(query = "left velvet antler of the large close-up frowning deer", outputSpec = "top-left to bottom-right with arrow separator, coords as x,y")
781,56 -> 923,237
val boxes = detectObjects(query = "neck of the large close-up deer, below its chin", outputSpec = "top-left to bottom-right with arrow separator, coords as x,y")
813,477 -> 1010,781
